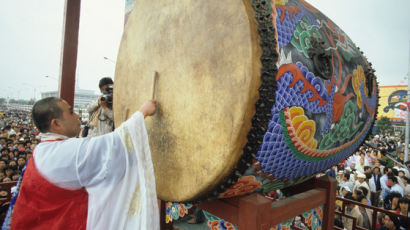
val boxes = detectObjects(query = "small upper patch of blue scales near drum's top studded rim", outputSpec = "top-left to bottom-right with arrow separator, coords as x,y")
276,8 -> 302,48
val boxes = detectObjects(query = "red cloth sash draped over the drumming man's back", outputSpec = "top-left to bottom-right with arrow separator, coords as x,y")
11,148 -> 88,230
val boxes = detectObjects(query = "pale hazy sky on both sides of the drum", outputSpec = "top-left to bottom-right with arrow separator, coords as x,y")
0,0 -> 410,99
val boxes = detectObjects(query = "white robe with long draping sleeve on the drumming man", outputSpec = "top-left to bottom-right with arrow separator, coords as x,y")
33,112 -> 159,230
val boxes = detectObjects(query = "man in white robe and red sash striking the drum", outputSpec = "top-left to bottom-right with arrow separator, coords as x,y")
3,98 -> 159,230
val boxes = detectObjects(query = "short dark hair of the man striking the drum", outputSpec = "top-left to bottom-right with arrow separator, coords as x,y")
31,97 -> 63,133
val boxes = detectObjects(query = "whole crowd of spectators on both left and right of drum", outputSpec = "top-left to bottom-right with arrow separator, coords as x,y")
0,100 -> 410,229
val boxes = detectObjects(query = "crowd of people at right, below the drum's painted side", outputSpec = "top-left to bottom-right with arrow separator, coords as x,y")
327,135 -> 410,229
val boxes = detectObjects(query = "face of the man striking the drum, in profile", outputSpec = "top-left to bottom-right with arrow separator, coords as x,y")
57,101 -> 81,137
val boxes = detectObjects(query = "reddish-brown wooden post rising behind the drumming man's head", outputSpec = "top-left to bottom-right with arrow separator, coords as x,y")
58,0 -> 81,106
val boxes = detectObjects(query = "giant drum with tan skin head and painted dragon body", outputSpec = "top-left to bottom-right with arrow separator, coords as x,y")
114,0 -> 378,201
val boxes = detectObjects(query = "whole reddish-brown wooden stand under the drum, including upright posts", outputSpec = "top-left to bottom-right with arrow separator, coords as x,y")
160,176 -> 336,230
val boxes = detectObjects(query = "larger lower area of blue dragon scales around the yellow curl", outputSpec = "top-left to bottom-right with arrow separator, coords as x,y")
256,63 -> 377,179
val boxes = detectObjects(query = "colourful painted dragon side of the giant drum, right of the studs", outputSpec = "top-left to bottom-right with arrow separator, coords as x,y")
219,0 -> 378,197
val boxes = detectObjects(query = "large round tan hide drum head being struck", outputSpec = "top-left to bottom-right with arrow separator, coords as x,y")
114,0 -> 262,201
